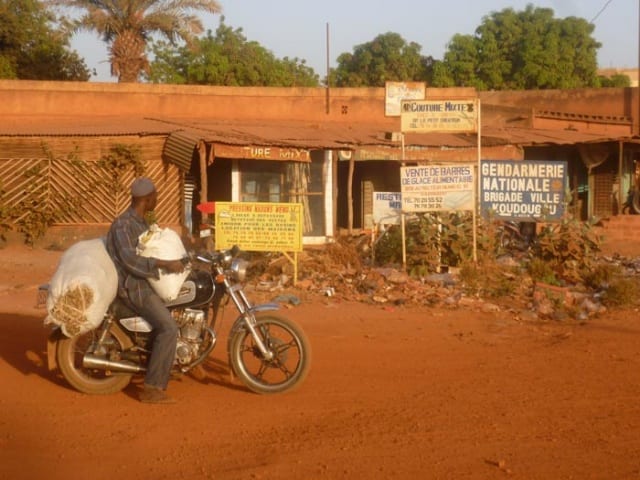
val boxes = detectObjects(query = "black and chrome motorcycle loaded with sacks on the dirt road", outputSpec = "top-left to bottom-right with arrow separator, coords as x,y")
41,247 -> 311,395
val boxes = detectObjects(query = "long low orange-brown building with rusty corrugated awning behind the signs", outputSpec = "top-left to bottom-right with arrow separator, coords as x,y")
0,81 -> 638,243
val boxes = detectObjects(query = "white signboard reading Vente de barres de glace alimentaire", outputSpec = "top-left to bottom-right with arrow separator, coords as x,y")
400,165 -> 475,212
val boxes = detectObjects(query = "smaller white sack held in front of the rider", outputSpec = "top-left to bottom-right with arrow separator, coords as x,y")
137,225 -> 189,302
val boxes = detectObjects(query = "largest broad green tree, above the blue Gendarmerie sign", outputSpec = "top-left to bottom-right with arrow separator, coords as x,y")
433,5 -> 601,90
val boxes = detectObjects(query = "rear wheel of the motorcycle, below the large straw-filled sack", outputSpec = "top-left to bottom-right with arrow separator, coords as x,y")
56,328 -> 133,395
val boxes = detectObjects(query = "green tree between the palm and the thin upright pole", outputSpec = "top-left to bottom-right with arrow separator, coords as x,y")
149,17 -> 319,87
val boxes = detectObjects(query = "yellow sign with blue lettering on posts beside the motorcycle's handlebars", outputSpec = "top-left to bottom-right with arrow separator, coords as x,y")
216,202 -> 302,252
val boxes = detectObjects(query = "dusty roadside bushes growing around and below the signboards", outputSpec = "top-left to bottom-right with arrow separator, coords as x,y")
373,214 -> 640,310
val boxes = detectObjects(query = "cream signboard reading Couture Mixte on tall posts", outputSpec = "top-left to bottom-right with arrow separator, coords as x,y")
400,99 -> 478,133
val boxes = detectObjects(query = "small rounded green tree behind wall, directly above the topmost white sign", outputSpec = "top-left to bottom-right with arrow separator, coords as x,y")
331,32 -> 433,87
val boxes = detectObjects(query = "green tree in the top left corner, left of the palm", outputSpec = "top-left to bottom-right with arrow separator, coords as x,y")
0,0 -> 90,81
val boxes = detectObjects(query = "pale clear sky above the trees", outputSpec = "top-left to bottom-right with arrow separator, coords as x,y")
71,0 -> 640,82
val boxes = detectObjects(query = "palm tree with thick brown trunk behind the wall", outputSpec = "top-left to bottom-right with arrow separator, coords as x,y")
47,0 -> 222,82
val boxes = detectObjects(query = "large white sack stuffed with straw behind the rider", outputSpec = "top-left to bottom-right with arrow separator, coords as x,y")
45,238 -> 118,337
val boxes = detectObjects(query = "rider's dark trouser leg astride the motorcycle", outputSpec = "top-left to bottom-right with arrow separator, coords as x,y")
135,293 -> 178,390
